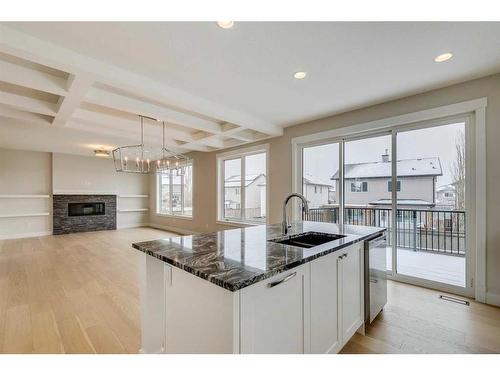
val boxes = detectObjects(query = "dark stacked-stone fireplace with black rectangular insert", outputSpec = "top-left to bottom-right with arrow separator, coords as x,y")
52,194 -> 116,234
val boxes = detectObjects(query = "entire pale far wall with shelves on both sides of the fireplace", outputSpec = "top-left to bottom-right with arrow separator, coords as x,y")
0,148 -> 150,239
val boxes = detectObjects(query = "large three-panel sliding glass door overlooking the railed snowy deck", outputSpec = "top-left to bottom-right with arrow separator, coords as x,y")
301,120 -> 472,295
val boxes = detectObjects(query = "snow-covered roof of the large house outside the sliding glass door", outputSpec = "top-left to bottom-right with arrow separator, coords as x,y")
331,157 -> 443,180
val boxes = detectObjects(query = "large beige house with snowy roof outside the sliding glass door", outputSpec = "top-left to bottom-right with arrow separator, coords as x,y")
331,154 -> 443,208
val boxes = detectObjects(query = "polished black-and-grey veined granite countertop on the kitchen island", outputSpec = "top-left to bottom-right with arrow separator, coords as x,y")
132,221 -> 385,292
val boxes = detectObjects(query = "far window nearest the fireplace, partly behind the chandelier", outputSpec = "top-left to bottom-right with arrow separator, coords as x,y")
156,164 -> 193,217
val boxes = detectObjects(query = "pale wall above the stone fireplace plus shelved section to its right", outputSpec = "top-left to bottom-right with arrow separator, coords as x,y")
53,154 -> 149,228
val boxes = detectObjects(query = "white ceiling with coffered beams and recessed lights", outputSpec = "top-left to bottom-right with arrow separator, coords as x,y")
0,22 -> 500,157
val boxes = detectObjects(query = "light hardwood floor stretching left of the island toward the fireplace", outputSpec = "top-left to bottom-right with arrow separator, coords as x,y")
0,228 -> 173,353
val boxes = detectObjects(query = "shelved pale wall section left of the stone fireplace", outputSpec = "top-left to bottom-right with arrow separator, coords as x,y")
0,149 -> 52,239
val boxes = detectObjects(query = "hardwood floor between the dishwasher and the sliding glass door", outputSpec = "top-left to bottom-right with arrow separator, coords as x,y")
342,281 -> 500,354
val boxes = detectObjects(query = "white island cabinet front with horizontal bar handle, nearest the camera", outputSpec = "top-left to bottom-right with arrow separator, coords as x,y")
240,264 -> 309,354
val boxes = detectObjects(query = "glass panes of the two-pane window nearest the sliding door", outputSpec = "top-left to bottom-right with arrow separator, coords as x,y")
218,149 -> 267,223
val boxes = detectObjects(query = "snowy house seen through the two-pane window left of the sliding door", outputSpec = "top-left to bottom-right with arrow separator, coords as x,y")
224,173 -> 266,217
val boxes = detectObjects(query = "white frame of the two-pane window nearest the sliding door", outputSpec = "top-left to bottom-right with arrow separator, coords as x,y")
216,144 -> 269,226
